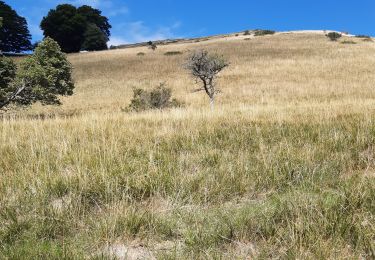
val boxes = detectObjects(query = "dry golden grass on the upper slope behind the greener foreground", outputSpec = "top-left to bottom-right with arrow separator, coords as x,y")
16,31 -> 375,114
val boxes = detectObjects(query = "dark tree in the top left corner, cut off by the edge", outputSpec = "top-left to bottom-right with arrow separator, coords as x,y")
0,1 -> 32,53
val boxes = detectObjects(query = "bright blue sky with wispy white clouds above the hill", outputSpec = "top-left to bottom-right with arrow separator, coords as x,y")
5,0 -> 375,45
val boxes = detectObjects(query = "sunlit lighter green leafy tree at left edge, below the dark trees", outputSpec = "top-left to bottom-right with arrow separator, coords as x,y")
0,38 -> 74,109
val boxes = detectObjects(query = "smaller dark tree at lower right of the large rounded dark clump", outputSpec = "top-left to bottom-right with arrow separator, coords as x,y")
82,24 -> 108,51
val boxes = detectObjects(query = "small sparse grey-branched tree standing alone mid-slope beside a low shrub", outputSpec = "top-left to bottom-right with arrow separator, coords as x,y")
186,50 -> 229,109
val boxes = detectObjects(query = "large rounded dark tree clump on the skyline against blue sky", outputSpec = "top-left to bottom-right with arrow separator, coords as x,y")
40,4 -> 111,53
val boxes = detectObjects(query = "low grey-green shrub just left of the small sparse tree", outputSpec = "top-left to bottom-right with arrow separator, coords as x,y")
127,83 -> 182,112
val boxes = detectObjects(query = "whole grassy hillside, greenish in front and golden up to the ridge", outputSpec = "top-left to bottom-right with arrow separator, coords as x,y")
0,34 -> 375,259
